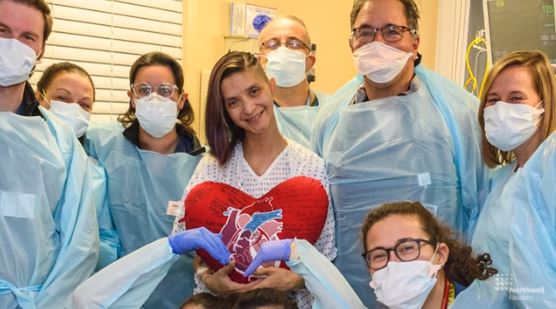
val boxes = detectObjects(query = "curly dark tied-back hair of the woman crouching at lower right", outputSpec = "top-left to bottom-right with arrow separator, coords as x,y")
361,201 -> 498,286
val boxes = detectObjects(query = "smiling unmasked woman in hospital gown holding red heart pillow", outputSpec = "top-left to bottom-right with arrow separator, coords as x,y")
176,52 -> 336,308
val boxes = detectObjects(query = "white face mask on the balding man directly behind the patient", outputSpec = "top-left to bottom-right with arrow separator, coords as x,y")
265,46 -> 307,88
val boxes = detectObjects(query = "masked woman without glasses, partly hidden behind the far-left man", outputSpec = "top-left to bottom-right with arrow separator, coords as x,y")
35,62 -> 120,269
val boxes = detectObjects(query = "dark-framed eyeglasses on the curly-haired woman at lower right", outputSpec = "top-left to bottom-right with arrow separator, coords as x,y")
361,238 -> 436,270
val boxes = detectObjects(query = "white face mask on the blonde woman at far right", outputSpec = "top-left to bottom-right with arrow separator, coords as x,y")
484,101 -> 544,151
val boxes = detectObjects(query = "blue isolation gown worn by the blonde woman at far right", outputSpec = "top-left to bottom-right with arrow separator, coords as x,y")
454,133 -> 556,308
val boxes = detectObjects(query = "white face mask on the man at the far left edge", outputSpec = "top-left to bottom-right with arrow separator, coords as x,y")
0,38 -> 37,87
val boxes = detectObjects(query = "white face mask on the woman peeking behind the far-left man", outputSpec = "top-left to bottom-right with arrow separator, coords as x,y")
50,100 -> 91,138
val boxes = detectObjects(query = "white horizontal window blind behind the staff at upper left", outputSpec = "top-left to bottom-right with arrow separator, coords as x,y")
31,0 -> 183,121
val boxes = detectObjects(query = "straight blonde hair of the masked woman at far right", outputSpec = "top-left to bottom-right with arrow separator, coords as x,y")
479,50 -> 556,167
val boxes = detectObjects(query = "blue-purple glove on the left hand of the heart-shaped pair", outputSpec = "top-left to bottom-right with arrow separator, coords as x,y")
168,227 -> 231,265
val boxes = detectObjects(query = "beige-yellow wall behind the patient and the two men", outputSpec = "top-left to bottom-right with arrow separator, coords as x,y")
183,0 -> 440,134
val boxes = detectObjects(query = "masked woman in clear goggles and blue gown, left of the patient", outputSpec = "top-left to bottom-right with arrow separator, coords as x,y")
85,52 -> 204,308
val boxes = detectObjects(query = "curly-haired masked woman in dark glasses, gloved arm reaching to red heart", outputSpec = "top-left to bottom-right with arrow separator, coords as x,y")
243,201 -> 497,309
